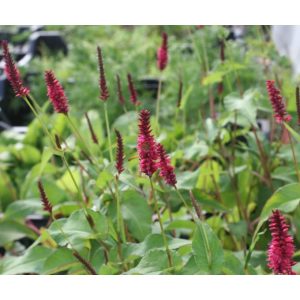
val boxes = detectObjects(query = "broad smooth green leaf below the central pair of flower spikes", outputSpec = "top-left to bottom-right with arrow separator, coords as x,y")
122,191 -> 152,241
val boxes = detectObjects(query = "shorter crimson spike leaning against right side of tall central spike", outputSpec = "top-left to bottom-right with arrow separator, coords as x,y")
157,144 -> 177,186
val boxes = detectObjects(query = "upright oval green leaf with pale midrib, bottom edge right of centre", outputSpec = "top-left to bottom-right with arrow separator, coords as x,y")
192,222 -> 224,274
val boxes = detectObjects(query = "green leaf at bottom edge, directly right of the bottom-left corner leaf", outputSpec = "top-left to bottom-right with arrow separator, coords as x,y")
42,248 -> 80,275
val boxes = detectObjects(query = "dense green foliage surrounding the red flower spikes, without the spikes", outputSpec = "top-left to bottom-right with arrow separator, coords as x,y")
0,26 -> 300,274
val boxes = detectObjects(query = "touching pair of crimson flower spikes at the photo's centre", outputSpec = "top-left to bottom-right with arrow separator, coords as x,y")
137,109 -> 176,186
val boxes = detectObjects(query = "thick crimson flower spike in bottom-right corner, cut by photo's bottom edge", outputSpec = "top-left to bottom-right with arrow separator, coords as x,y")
268,210 -> 296,275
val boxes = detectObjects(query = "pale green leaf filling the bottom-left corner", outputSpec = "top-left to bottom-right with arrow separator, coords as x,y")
1,246 -> 52,275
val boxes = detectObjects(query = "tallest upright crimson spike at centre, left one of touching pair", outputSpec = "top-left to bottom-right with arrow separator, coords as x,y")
137,109 -> 158,177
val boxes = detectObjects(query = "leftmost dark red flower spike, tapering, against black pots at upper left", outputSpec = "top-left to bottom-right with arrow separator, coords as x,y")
1,41 -> 30,97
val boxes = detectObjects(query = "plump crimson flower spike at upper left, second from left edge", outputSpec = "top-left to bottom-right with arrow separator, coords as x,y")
45,70 -> 69,115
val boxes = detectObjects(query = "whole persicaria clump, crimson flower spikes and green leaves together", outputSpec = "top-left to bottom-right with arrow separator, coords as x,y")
0,25 -> 300,275
